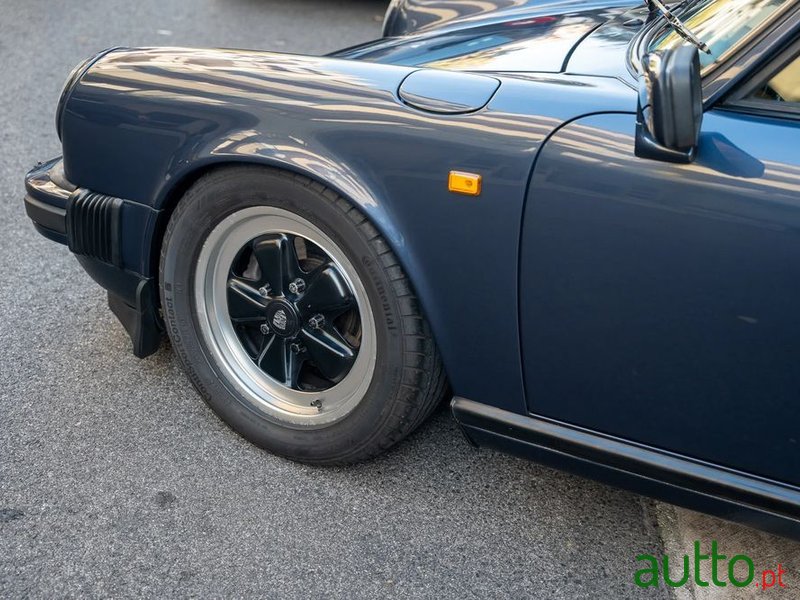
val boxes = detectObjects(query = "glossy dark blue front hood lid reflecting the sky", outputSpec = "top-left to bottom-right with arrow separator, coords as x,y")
334,0 -> 641,72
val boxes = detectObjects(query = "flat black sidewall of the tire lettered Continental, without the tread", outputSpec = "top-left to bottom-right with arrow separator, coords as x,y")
161,168 -> 404,460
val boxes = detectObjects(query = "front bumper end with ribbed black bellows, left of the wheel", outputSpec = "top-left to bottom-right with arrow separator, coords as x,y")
25,158 -> 163,358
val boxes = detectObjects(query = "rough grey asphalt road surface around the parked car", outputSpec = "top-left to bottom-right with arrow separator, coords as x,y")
0,0 -> 800,598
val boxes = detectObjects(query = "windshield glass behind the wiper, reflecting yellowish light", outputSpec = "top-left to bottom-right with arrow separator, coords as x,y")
648,0 -> 790,68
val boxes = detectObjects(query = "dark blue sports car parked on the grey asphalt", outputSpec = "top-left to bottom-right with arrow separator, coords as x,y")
25,0 -> 800,538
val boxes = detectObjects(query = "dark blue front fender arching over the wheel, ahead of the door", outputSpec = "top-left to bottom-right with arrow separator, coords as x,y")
63,49 -> 635,412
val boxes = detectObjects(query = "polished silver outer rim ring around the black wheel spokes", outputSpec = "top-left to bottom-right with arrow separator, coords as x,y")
194,206 -> 377,427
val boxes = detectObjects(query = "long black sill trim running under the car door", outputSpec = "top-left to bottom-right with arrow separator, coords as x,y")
451,397 -> 800,540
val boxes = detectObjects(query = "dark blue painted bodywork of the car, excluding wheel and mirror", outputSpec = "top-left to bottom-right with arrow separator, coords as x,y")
21,0 -> 800,527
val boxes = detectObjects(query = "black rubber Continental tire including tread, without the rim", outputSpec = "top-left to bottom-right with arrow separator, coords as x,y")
160,166 -> 447,464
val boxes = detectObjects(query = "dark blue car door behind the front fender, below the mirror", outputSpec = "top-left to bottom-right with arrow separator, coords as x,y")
520,44 -> 800,484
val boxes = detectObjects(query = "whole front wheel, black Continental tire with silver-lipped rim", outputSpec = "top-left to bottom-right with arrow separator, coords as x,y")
156,167 -> 445,463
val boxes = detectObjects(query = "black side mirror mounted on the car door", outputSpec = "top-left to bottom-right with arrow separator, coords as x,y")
636,46 -> 703,163
